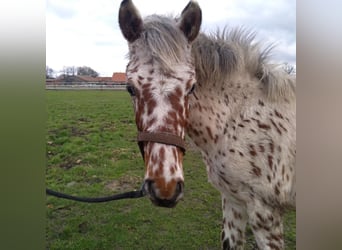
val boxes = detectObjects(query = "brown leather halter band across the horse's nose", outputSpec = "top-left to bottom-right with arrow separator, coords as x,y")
137,131 -> 185,159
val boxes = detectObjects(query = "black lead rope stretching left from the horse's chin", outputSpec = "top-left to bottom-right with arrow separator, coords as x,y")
46,187 -> 146,203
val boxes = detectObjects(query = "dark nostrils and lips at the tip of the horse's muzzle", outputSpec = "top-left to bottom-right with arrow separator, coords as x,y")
144,180 -> 184,208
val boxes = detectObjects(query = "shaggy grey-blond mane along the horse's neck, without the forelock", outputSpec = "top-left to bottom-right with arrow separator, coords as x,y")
192,28 -> 296,100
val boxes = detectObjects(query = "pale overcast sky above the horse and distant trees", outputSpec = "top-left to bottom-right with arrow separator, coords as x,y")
46,0 -> 296,76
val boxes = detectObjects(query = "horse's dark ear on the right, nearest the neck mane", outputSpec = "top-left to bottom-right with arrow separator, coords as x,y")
179,0 -> 202,42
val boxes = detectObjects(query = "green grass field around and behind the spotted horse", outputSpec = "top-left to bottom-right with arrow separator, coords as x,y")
46,90 -> 296,250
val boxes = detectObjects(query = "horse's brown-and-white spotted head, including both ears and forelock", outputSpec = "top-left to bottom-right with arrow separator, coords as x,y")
119,0 -> 202,207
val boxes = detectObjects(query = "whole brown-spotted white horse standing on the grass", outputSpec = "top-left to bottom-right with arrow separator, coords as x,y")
119,0 -> 296,249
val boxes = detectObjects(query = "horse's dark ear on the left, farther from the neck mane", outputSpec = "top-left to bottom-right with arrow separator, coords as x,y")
119,0 -> 143,43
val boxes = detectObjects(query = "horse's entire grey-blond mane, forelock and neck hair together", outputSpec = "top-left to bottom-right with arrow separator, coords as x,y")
139,15 -> 296,100
